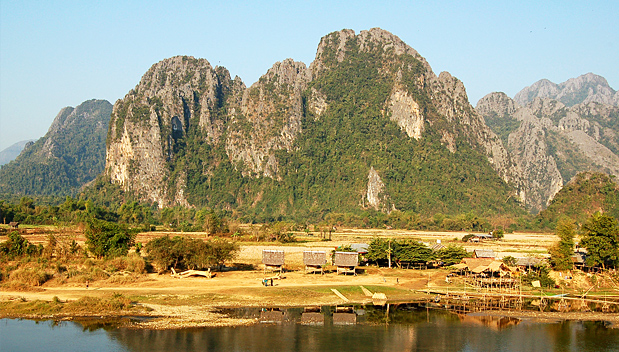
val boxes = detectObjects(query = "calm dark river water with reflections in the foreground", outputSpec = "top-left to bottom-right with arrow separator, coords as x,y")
0,305 -> 619,352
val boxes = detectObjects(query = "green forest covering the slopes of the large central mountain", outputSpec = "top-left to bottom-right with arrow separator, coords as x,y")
179,34 -> 521,222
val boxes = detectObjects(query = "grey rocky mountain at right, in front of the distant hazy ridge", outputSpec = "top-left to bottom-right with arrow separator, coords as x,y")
476,91 -> 619,211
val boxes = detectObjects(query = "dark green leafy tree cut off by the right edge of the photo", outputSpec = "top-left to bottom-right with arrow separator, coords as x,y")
580,212 -> 619,269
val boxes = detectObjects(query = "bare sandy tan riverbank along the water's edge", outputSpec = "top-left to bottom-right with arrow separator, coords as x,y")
0,267 -> 619,329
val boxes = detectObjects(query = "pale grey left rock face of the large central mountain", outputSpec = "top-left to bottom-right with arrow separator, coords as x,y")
106,56 -> 231,206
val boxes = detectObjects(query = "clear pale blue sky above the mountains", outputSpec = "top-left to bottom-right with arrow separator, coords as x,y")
0,0 -> 619,150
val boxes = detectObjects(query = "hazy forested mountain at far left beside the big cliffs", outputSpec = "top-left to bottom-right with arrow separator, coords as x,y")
0,99 -> 112,196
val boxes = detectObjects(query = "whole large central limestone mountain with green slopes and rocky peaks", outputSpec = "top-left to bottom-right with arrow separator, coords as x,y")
105,28 -> 523,217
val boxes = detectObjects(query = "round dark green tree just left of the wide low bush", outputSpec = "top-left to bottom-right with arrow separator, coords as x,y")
84,219 -> 135,258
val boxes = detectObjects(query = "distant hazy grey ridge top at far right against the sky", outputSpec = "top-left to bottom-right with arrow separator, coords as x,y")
514,73 -> 619,106
